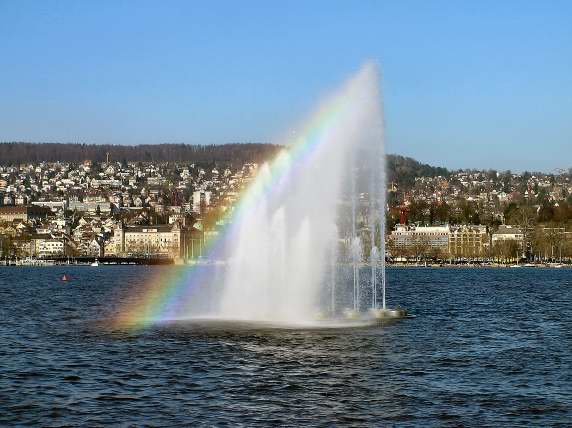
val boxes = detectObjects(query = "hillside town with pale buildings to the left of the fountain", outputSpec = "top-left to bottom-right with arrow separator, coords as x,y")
0,160 -> 257,263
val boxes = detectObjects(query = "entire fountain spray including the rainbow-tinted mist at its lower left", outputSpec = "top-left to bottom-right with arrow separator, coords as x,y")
115,64 -> 407,328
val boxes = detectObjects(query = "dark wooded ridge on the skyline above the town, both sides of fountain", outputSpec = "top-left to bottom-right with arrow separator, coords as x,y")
0,143 -> 449,185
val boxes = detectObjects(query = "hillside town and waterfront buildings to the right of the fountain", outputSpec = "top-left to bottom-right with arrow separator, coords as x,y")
387,169 -> 572,263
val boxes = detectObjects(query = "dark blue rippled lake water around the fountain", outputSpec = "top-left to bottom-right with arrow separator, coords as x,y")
0,266 -> 572,427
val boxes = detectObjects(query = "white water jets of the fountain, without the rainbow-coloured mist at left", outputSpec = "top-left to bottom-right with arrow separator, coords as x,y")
217,64 -> 405,324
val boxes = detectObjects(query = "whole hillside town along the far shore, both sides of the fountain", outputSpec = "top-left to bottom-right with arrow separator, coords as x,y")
0,156 -> 572,264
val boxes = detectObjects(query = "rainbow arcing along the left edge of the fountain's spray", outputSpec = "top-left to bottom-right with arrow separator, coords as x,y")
113,84 -> 349,330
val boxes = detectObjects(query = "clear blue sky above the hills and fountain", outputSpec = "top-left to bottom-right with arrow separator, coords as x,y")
0,0 -> 572,171
